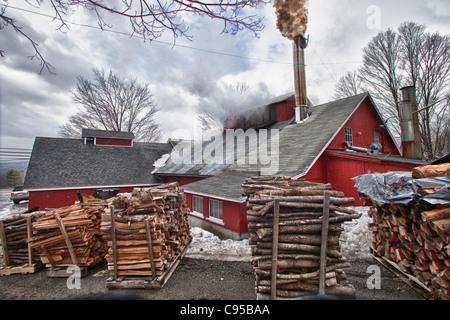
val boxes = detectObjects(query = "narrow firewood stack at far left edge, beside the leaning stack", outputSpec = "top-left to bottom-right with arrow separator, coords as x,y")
0,214 -> 39,267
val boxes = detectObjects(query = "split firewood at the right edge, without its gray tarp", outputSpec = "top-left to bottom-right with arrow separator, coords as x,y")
367,164 -> 450,299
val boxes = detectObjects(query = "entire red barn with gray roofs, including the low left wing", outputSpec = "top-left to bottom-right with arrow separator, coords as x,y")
24,93 -> 423,239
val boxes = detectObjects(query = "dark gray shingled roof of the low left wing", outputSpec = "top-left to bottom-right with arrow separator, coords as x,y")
24,137 -> 172,189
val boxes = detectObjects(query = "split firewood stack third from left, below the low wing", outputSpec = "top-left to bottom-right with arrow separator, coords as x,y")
102,183 -> 191,277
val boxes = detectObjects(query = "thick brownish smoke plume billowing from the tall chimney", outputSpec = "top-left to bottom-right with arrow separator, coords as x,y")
274,0 -> 308,40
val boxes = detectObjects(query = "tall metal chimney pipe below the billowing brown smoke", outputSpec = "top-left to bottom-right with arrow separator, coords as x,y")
293,34 -> 308,122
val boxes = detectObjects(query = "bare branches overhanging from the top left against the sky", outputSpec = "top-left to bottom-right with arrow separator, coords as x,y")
0,0 -> 270,73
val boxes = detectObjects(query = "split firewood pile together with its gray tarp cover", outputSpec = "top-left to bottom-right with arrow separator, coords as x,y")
357,164 -> 450,299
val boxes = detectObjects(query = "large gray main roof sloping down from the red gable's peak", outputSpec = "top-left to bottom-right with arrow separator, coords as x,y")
157,93 -> 367,177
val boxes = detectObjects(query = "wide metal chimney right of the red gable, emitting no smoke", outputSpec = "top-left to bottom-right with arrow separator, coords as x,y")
398,86 -> 422,160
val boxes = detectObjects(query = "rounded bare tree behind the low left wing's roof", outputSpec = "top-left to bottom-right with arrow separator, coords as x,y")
59,69 -> 162,142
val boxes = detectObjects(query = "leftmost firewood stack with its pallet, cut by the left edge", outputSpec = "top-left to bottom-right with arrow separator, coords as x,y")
0,212 -> 41,276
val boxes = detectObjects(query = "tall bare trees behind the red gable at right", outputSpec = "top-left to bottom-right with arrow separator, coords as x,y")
335,22 -> 450,159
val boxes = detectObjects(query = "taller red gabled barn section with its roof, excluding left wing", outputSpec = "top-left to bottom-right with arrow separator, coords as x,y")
155,93 -> 423,239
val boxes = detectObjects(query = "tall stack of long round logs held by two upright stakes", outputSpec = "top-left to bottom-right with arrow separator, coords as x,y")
242,176 -> 361,299
